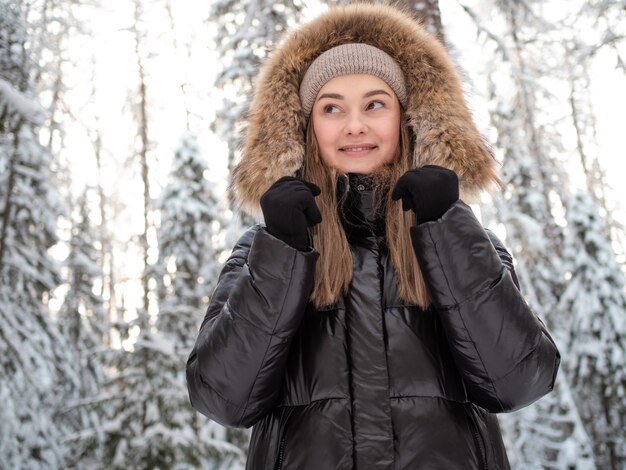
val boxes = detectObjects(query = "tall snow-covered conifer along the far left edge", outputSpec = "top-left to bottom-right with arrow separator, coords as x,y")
0,0 -> 79,469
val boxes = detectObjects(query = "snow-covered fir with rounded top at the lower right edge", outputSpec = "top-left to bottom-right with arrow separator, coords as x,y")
559,192 -> 626,470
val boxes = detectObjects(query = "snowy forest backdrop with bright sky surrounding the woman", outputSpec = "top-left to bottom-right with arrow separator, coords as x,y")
0,0 -> 626,470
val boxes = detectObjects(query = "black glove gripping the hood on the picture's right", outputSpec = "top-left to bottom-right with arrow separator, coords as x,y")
391,165 -> 459,225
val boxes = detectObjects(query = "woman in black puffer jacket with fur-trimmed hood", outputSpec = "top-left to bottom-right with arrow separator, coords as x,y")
187,5 -> 559,470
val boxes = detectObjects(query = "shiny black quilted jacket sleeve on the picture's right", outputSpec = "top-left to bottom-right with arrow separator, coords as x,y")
411,201 -> 560,413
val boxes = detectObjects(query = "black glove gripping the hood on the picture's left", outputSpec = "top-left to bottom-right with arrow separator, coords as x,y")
261,176 -> 322,251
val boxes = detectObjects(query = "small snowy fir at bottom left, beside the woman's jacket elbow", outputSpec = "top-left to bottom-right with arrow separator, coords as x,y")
92,311 -> 243,470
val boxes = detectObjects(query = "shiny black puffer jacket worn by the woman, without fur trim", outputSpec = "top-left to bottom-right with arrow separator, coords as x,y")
187,182 -> 559,470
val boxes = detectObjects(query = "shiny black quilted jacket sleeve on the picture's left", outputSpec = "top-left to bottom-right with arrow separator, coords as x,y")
187,227 -> 318,427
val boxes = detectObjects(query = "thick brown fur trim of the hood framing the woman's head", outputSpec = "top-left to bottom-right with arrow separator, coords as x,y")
231,4 -> 498,213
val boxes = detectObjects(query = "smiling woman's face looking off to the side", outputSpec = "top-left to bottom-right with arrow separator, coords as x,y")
311,74 -> 400,173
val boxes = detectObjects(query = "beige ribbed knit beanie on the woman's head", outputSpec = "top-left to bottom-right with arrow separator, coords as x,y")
300,43 -> 407,118
